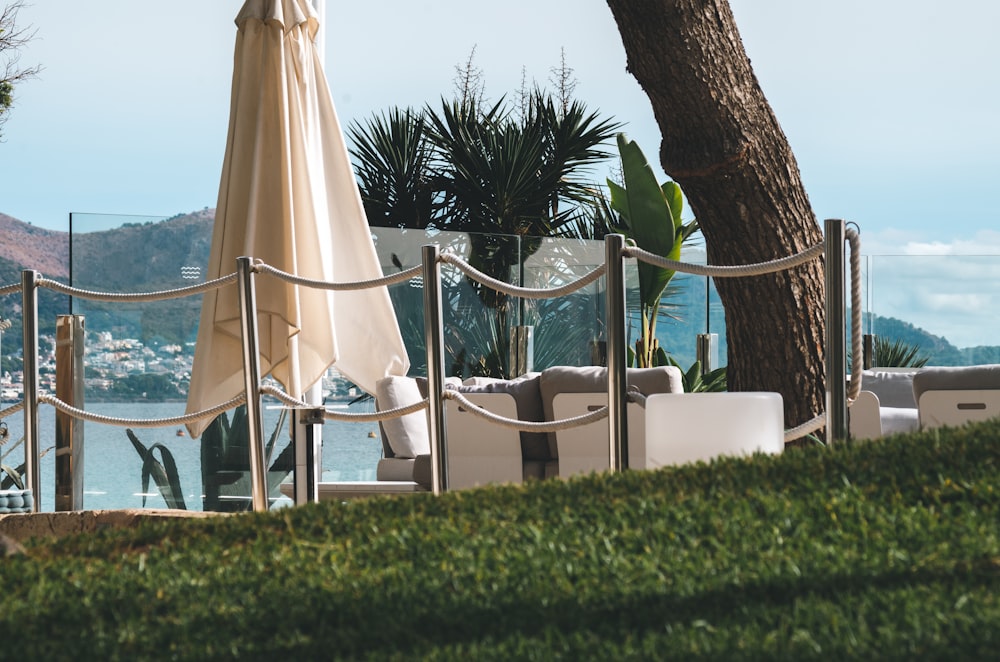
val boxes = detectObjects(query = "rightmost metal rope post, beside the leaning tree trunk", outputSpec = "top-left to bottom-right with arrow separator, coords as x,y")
824,219 -> 847,443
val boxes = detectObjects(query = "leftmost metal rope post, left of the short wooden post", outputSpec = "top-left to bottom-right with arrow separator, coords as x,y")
21,269 -> 42,513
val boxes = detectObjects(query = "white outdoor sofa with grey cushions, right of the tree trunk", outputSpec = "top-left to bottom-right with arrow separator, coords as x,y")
848,364 -> 1000,439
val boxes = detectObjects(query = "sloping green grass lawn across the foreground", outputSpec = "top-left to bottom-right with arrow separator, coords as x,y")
0,423 -> 1000,660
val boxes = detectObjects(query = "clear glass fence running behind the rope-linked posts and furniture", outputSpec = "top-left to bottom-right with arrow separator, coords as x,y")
0,210 -> 1000,510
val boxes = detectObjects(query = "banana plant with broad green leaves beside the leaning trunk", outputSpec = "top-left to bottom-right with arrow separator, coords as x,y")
608,133 -> 698,368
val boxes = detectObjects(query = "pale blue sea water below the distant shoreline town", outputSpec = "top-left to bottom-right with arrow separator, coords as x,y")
0,402 -> 382,512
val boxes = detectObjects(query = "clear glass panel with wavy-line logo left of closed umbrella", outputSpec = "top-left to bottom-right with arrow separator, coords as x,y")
65,211 -> 248,510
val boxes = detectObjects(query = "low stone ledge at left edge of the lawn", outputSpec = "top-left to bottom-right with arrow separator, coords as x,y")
0,509 -> 219,542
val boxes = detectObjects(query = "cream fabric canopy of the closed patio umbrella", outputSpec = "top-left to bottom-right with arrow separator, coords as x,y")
187,0 -> 409,437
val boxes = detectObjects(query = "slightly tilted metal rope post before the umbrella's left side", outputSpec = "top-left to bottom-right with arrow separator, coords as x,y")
236,257 -> 268,512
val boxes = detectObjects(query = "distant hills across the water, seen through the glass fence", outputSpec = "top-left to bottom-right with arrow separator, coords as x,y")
0,209 -> 1000,366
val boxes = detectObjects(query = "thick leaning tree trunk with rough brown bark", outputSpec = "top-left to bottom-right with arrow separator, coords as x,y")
608,0 -> 825,427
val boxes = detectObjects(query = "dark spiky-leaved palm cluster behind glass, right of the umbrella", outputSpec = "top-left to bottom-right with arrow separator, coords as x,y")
349,85 -> 619,376
